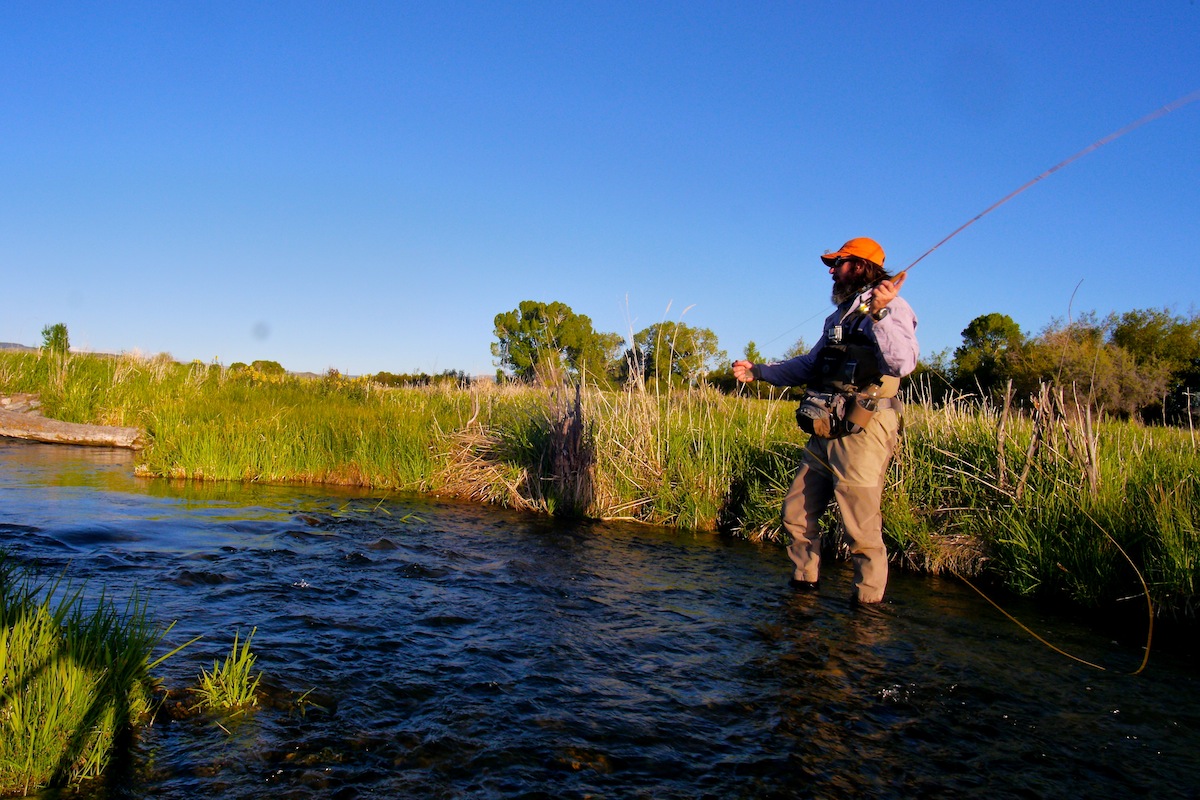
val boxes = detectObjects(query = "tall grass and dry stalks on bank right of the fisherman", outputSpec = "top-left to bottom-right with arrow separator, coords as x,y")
884,404 -> 1200,616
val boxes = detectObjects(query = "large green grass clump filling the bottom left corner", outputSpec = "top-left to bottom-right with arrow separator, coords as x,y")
0,559 -> 166,795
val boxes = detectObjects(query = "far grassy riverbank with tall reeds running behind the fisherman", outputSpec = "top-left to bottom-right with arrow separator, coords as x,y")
0,353 -> 1200,619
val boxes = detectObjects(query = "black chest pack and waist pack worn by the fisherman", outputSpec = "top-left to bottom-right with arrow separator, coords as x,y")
796,313 -> 900,439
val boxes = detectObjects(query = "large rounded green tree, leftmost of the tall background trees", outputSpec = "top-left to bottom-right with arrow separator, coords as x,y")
492,300 -> 625,385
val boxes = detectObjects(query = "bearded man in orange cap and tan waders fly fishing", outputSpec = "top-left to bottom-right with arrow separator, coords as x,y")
733,237 -> 917,603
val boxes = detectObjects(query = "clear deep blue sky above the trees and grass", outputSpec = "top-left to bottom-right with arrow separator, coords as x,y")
0,0 -> 1200,374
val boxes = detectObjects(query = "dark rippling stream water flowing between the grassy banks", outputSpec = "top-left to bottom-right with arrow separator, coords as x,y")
0,439 -> 1200,798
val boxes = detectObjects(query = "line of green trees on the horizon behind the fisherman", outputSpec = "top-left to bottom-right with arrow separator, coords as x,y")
492,300 -> 1200,425
